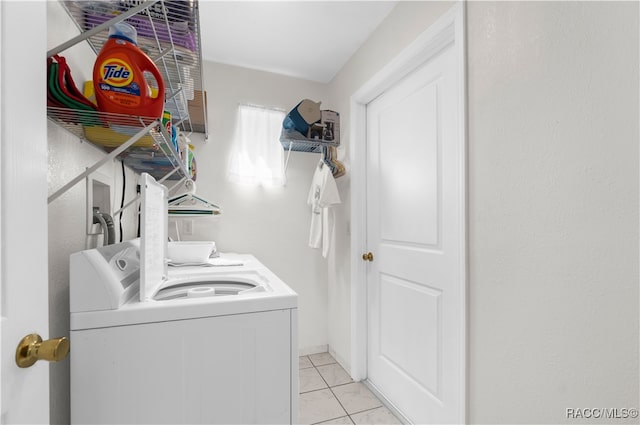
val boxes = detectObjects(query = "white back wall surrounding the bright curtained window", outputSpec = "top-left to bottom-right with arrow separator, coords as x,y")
180,62 -> 327,353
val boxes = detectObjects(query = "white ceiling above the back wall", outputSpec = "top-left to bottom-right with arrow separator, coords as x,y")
199,0 -> 397,83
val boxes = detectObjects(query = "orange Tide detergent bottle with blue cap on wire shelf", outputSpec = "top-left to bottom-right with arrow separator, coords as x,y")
93,22 -> 164,119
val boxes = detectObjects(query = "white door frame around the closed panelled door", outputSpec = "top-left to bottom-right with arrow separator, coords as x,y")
349,1 -> 468,423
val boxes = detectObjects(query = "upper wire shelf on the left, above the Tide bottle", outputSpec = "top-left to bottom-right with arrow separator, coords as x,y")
56,0 -> 207,134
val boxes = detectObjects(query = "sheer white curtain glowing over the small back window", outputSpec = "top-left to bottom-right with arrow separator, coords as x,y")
228,105 -> 285,186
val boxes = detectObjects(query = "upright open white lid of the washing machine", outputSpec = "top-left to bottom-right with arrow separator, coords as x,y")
140,173 -> 169,302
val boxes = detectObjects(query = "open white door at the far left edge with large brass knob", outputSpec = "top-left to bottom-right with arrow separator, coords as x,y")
0,1 -> 49,424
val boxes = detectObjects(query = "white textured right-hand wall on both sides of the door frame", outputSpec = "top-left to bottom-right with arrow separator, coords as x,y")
328,2 -> 640,423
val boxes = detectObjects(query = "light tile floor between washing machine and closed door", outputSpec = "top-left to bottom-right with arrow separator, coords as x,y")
299,353 -> 401,425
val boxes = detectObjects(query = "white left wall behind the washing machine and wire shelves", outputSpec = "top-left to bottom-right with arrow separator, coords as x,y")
43,2 -> 137,424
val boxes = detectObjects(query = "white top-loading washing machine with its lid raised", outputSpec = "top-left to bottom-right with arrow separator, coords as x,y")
70,174 -> 298,424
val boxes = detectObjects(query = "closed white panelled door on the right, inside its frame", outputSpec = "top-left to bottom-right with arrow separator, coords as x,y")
366,36 -> 465,424
